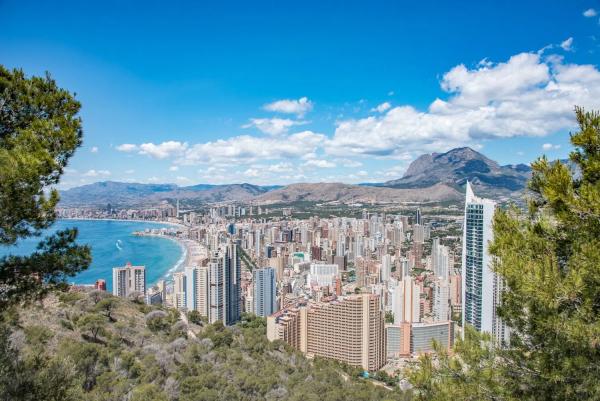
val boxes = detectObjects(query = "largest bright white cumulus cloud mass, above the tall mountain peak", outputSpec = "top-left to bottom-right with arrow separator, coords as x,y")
325,53 -> 600,159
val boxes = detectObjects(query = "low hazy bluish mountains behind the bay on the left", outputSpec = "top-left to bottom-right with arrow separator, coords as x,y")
60,181 -> 278,207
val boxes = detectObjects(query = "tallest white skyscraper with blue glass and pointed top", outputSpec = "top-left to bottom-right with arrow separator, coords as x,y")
462,182 -> 507,341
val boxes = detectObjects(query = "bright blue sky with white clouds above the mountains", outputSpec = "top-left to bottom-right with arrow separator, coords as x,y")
0,0 -> 600,188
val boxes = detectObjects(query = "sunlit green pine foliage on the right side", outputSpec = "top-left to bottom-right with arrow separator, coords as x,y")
408,108 -> 600,400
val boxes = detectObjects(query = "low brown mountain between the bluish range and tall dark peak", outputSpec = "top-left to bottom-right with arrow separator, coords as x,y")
254,183 -> 463,203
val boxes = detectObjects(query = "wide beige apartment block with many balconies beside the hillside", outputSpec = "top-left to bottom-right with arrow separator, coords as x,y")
267,294 -> 386,371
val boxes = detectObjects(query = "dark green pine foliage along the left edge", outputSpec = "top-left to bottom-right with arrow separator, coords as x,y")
0,65 -> 91,310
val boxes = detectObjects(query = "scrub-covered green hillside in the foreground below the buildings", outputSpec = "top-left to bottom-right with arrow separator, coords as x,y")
0,291 -> 408,401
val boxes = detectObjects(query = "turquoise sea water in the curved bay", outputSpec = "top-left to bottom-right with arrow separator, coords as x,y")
0,220 -> 183,291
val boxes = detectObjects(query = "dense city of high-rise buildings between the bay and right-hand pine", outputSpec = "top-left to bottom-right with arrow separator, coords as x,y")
58,180 -> 502,373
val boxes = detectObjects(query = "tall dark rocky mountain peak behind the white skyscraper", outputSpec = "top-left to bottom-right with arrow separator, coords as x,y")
383,147 -> 531,196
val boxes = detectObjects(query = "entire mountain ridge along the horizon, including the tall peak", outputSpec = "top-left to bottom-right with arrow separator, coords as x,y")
60,147 -> 531,206
